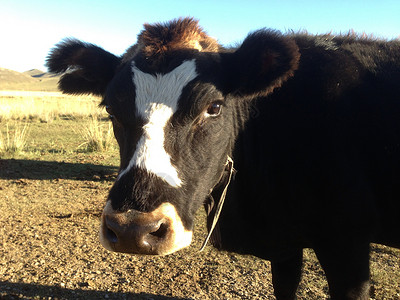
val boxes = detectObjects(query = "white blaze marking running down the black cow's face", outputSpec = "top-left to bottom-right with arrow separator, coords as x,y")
118,59 -> 197,187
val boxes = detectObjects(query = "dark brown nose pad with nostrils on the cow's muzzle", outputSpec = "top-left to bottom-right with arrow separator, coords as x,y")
102,215 -> 169,254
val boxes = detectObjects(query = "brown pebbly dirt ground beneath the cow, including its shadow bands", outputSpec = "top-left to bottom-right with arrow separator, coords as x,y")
0,155 -> 400,299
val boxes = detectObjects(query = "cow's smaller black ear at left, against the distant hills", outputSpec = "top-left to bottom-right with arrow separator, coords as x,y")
46,39 -> 120,96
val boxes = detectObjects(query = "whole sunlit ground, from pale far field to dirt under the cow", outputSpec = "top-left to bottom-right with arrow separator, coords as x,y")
0,92 -> 400,300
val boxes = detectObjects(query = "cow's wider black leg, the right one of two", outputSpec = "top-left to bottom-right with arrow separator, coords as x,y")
314,240 -> 370,300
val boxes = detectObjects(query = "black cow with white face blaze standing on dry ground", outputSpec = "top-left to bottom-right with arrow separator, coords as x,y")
48,18 -> 400,299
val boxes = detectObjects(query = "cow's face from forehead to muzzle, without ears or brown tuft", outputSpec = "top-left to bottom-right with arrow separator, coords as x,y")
100,58 -> 233,254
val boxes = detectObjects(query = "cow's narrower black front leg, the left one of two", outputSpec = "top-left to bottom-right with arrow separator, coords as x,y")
271,249 -> 303,300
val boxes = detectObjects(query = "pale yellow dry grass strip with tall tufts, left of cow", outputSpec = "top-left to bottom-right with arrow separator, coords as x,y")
0,91 -> 114,156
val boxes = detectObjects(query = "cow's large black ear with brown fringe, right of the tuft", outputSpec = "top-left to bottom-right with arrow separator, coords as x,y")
221,30 -> 300,98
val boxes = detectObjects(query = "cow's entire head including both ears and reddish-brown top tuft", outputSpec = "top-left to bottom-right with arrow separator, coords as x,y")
48,19 -> 299,254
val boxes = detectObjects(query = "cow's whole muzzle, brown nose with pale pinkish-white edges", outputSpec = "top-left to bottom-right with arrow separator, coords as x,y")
100,201 -> 193,255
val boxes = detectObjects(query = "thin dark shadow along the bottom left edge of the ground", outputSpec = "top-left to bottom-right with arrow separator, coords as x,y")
0,281 -> 187,300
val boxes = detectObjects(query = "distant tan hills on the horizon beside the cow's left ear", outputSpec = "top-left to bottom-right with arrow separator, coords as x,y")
0,68 -> 59,92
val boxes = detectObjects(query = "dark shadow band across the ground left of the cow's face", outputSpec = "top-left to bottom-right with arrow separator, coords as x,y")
0,159 -> 118,181
